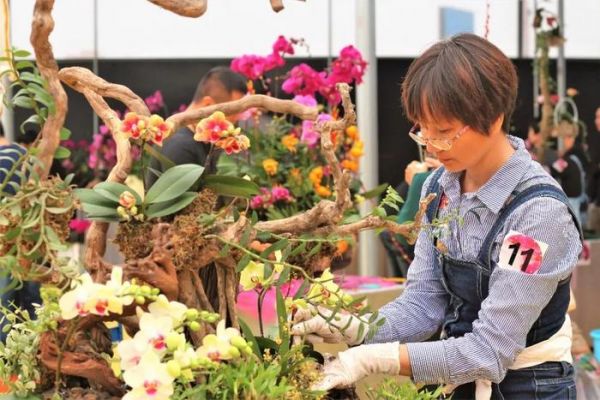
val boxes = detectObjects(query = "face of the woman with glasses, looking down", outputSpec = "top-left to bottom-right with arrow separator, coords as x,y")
420,118 -> 504,172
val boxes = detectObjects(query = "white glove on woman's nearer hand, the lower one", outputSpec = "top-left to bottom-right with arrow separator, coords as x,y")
312,342 -> 400,391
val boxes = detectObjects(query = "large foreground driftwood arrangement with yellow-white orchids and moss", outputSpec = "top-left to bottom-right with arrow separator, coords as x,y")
0,4 -> 440,400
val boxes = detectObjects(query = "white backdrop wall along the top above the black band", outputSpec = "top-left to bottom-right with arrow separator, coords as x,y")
11,0 -> 600,59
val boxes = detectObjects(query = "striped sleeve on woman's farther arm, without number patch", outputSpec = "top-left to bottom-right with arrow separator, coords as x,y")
369,176 -> 448,343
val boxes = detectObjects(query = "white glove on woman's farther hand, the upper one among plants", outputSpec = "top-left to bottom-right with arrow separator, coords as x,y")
291,305 -> 369,346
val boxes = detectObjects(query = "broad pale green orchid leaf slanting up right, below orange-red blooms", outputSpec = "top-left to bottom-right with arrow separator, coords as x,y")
145,164 -> 204,204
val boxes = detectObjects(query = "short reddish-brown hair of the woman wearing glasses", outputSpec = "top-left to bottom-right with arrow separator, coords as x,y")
402,33 -> 518,134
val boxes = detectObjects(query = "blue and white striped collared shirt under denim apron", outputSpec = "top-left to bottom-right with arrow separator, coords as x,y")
371,136 -> 581,384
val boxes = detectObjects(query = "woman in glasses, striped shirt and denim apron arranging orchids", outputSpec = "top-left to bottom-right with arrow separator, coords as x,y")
292,34 -> 581,400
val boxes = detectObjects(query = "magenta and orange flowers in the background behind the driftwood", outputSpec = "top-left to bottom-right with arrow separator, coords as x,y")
219,36 -> 367,220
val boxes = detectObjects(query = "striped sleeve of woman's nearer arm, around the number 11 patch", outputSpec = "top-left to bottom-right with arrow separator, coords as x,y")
407,197 -> 581,384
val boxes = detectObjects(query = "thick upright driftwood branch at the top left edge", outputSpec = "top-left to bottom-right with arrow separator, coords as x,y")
30,0 -> 67,178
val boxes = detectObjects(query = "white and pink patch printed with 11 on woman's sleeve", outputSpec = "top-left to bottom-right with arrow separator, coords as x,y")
498,231 -> 548,274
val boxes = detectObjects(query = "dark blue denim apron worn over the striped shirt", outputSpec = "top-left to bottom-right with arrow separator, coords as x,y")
427,168 -> 581,400
